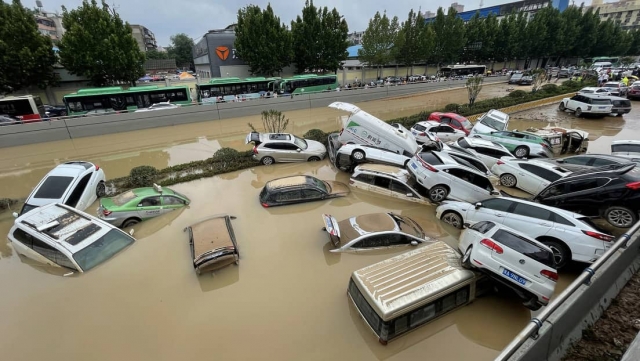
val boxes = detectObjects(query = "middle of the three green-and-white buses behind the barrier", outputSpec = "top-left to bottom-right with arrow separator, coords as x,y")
196,77 -> 280,104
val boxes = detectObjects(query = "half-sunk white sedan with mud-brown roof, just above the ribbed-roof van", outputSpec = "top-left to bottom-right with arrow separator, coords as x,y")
322,212 -> 430,252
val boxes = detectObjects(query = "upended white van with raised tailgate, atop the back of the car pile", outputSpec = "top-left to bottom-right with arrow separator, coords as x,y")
329,102 -> 420,157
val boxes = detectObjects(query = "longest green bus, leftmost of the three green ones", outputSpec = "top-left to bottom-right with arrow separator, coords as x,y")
62,85 -> 191,115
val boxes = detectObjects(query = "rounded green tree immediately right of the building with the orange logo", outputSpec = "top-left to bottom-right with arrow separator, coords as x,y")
235,4 -> 291,76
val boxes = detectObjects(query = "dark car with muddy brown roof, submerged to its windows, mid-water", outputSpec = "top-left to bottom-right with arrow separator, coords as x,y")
259,175 -> 349,208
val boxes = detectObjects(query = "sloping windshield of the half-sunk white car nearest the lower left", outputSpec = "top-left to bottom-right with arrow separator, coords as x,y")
73,229 -> 134,272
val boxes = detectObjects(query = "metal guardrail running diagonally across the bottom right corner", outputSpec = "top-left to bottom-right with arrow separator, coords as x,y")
495,222 -> 640,361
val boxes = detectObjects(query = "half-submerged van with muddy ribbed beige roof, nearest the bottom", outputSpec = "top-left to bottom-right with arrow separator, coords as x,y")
347,241 -> 487,345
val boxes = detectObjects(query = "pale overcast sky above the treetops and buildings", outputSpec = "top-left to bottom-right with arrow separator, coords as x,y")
25,0 -> 590,46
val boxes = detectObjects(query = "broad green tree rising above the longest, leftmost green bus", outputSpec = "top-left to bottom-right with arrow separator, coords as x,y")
59,0 -> 144,86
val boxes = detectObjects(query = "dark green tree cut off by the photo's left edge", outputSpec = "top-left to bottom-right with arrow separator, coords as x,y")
0,0 -> 57,94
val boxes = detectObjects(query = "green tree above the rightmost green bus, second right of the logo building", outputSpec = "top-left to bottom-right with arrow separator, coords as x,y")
291,0 -> 349,73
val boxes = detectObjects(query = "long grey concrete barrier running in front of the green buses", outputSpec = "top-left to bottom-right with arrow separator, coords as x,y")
0,77 -> 505,148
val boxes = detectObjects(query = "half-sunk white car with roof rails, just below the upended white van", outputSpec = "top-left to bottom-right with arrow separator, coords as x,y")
349,164 -> 432,205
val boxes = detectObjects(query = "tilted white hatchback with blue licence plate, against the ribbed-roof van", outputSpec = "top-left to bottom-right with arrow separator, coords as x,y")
458,221 -> 558,311
